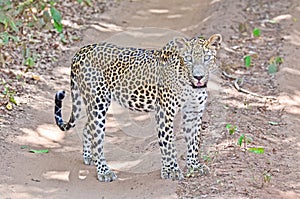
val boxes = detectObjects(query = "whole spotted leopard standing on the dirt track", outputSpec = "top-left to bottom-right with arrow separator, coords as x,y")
54,34 -> 222,182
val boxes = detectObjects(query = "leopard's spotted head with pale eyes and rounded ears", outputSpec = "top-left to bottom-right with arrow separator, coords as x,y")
174,34 -> 222,88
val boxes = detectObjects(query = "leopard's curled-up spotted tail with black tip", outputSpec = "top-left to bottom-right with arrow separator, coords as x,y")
54,77 -> 82,131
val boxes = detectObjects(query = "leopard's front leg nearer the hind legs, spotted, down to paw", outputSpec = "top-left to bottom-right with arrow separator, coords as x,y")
156,101 -> 184,180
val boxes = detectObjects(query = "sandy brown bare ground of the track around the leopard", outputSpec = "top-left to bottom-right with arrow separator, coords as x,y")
0,0 -> 300,199
